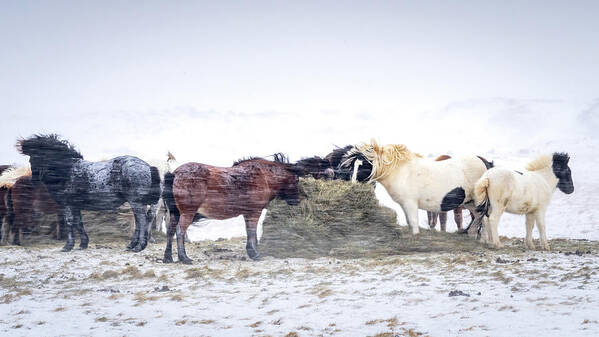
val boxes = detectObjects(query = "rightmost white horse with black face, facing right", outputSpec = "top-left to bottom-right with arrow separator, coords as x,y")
474,152 -> 574,251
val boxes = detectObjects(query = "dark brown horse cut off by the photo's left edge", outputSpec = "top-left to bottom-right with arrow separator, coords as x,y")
0,166 -> 64,245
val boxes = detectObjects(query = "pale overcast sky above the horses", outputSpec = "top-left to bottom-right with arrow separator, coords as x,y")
0,1 -> 599,165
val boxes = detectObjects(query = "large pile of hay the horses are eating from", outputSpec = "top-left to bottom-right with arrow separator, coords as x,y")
260,178 -> 401,258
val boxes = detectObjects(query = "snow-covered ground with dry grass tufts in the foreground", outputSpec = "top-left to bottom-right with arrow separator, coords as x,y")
0,240 -> 599,336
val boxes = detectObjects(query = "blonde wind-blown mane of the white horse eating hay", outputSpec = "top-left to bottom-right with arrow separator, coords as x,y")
356,139 -> 422,181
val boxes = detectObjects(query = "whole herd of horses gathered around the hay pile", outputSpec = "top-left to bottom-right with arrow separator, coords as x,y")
0,134 -> 574,263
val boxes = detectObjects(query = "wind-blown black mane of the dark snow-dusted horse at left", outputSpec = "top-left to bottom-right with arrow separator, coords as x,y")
16,133 -> 83,159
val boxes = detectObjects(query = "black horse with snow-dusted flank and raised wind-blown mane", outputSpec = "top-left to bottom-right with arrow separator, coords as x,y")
17,134 -> 161,252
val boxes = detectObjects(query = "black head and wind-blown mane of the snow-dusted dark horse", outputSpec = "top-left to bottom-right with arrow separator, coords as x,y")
16,134 -> 83,184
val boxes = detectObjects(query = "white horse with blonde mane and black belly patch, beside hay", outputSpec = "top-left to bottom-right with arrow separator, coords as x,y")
343,140 -> 493,235
